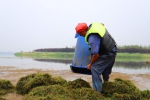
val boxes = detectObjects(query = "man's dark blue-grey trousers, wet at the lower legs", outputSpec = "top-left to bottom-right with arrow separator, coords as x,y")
91,52 -> 116,93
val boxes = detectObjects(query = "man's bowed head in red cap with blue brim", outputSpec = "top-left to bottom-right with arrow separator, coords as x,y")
75,23 -> 88,38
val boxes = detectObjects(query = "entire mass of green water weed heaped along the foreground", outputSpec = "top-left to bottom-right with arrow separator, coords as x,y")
0,73 -> 150,100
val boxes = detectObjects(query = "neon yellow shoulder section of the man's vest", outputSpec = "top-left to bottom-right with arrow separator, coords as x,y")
85,22 -> 106,44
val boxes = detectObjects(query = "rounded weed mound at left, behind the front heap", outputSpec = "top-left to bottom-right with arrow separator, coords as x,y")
16,73 -> 67,95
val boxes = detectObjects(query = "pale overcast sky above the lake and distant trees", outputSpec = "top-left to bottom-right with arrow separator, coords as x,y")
0,0 -> 150,52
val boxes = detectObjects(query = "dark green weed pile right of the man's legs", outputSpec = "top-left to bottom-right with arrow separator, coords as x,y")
102,78 -> 150,100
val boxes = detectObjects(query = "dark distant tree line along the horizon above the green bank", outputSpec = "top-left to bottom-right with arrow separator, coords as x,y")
34,45 -> 150,53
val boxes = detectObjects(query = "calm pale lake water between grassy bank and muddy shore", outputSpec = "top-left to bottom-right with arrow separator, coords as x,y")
0,52 -> 150,74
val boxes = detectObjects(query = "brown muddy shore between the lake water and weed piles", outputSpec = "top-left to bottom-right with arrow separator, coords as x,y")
0,66 -> 150,100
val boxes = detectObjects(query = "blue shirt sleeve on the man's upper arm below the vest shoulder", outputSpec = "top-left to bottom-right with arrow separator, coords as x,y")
88,34 -> 101,54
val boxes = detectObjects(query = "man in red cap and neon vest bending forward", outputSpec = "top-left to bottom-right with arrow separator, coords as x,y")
75,22 -> 117,93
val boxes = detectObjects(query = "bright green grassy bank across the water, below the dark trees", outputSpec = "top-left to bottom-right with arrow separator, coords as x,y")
15,52 -> 150,62
